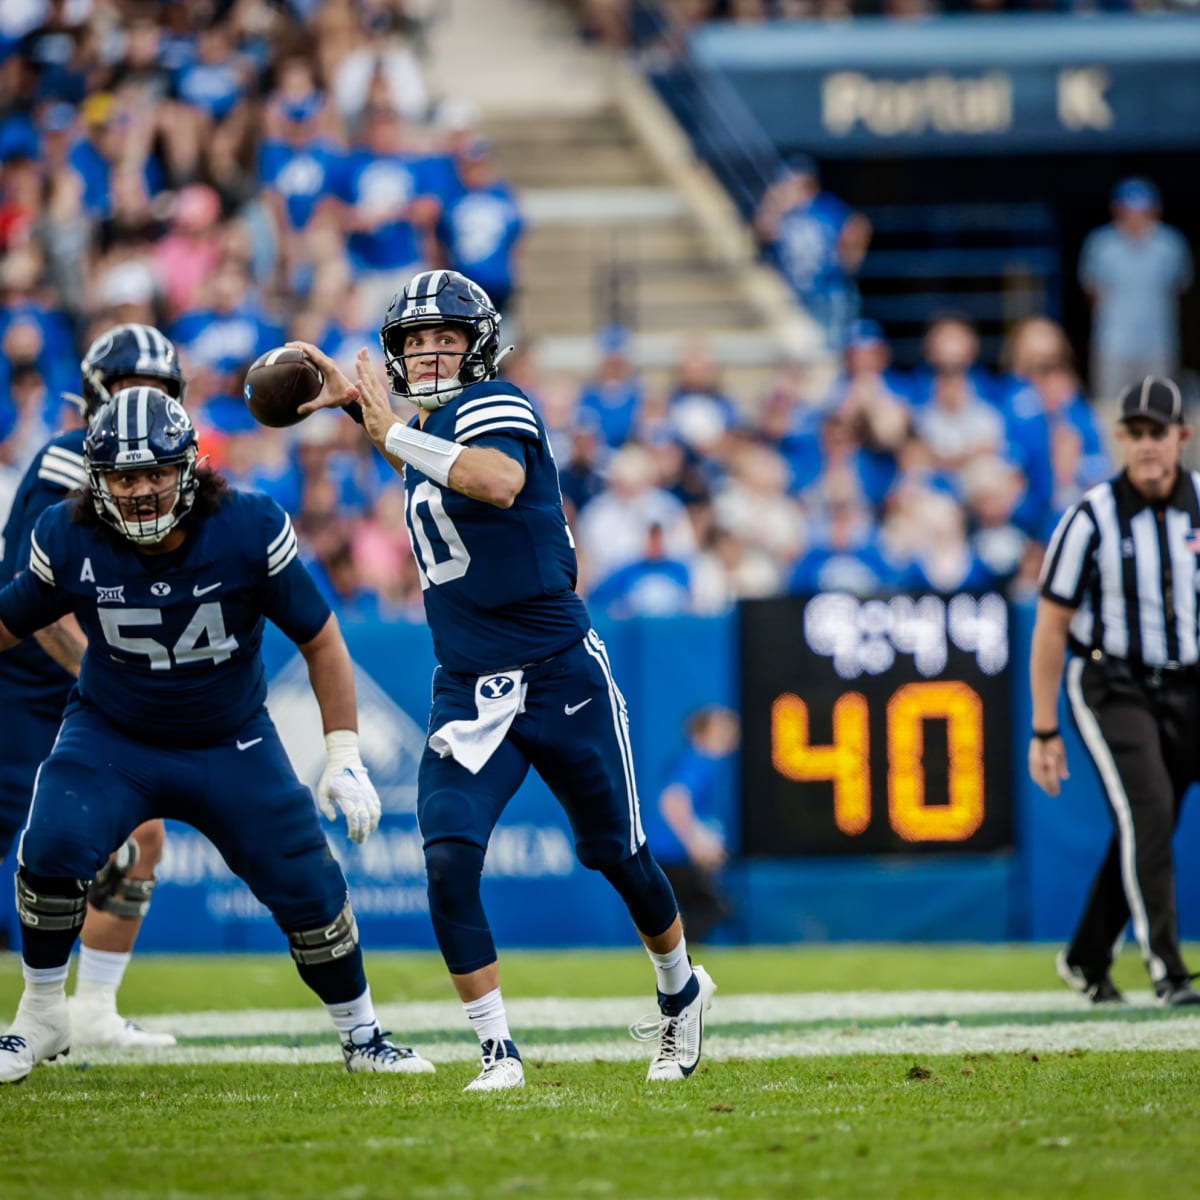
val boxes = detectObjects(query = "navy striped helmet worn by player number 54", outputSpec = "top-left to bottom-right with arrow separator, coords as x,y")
83,388 -> 199,546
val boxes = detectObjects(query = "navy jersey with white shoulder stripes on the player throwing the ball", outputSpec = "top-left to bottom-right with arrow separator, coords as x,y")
404,380 -> 590,674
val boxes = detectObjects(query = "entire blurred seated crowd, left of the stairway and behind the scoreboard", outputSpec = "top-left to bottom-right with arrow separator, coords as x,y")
0,0 -> 1109,620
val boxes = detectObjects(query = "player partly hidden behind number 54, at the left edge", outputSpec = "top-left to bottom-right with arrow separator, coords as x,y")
0,324 -> 186,1046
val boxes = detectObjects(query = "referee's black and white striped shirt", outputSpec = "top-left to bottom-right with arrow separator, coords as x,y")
1042,470 -> 1200,667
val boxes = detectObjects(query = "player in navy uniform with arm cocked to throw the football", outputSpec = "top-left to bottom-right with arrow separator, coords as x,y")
290,271 -> 716,1091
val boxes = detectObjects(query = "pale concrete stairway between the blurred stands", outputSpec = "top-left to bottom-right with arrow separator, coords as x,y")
417,0 -> 820,401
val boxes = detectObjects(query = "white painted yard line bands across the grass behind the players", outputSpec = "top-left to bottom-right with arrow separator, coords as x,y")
54,991 -> 1200,1066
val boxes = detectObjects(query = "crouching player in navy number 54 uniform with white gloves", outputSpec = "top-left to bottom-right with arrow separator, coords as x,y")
0,388 -> 433,1082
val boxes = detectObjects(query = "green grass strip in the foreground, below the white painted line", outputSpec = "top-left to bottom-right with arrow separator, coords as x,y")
0,1054 -> 1200,1200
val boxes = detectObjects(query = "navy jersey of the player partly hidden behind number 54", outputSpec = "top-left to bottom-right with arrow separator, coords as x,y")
0,430 -> 86,716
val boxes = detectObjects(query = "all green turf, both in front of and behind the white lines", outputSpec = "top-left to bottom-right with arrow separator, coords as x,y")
0,947 -> 1200,1200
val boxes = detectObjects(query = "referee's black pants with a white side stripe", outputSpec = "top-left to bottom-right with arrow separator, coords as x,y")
1067,659 -> 1200,986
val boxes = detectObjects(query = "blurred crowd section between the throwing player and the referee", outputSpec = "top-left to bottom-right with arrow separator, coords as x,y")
522,314 -> 1111,617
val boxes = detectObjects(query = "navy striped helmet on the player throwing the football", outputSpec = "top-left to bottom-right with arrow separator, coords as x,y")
379,271 -> 504,408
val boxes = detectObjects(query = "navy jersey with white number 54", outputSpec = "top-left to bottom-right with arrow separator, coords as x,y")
0,491 -> 330,746
